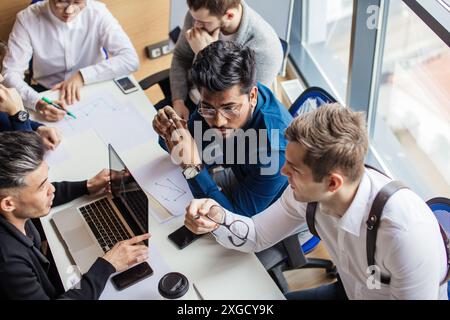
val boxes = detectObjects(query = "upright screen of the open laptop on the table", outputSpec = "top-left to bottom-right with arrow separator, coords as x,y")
108,145 -> 148,235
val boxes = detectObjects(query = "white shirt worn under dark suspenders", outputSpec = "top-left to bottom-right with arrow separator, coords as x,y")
213,170 -> 447,300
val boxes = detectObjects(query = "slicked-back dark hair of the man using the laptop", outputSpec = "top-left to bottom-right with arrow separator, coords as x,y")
0,131 -> 45,194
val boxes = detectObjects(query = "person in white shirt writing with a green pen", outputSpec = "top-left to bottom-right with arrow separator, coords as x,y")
3,0 -> 139,121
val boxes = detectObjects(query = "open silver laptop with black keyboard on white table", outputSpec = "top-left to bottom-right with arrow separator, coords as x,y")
52,145 -> 148,273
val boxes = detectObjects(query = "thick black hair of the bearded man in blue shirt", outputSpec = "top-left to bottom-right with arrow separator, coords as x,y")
191,40 -> 256,94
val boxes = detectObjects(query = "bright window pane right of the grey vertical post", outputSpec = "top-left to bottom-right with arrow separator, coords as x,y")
372,1 -> 450,199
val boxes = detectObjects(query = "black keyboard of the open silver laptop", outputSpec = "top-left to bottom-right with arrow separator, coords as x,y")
79,198 -> 131,253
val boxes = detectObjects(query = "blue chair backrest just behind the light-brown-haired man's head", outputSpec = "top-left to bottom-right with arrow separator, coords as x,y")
289,87 -> 337,117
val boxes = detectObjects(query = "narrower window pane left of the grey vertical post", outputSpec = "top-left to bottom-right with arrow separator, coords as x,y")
291,0 -> 353,101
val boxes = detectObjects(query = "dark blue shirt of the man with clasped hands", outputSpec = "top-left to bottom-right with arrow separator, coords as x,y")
160,84 -> 292,217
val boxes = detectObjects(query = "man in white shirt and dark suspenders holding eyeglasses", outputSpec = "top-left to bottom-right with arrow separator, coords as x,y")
185,104 -> 447,299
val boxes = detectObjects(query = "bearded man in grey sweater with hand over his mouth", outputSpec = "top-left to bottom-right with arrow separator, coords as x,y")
165,0 -> 283,120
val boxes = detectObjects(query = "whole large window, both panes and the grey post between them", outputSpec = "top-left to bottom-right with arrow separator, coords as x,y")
290,0 -> 450,199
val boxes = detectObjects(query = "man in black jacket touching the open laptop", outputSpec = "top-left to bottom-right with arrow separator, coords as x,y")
0,132 -> 149,299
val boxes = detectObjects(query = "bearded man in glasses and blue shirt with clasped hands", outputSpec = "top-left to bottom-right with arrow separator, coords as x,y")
153,41 -> 292,216
